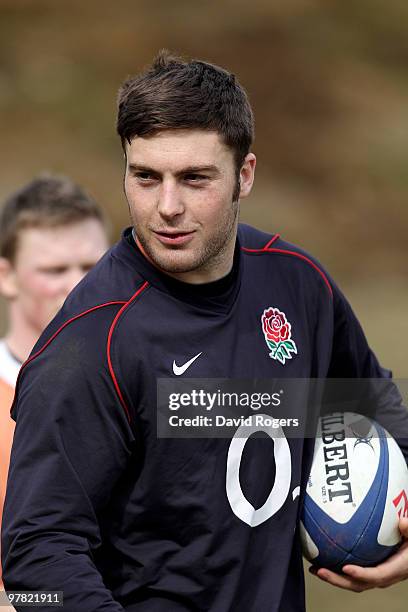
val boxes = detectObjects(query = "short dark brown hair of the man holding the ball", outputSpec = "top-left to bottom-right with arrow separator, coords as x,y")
117,50 -> 254,173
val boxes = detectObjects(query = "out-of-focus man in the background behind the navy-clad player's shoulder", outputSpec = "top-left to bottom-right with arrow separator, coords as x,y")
0,175 -> 108,584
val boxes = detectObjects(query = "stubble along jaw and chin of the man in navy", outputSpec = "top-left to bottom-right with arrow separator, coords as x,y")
133,200 -> 239,274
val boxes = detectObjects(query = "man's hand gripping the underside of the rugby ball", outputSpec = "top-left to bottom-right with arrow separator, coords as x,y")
309,518 -> 408,593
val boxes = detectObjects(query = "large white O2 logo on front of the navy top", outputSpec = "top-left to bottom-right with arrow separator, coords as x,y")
226,415 -> 299,527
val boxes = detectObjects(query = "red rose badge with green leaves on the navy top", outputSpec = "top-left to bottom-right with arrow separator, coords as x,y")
261,306 -> 297,365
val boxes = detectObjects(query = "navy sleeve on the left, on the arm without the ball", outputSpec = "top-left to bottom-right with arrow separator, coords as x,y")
2,314 -> 133,612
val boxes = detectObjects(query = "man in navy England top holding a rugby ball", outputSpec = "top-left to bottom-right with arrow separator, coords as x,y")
3,54 -> 408,612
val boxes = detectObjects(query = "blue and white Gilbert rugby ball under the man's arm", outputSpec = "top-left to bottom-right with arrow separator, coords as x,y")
300,412 -> 408,571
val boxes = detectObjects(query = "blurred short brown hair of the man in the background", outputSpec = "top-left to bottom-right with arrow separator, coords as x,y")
0,174 -> 106,261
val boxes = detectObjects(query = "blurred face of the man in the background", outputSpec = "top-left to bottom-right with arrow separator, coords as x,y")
5,219 -> 108,334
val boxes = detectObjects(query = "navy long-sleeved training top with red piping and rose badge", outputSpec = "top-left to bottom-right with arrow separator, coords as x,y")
2,225 -> 408,612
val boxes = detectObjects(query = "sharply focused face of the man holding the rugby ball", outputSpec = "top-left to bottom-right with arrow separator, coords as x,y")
125,130 -> 255,283
